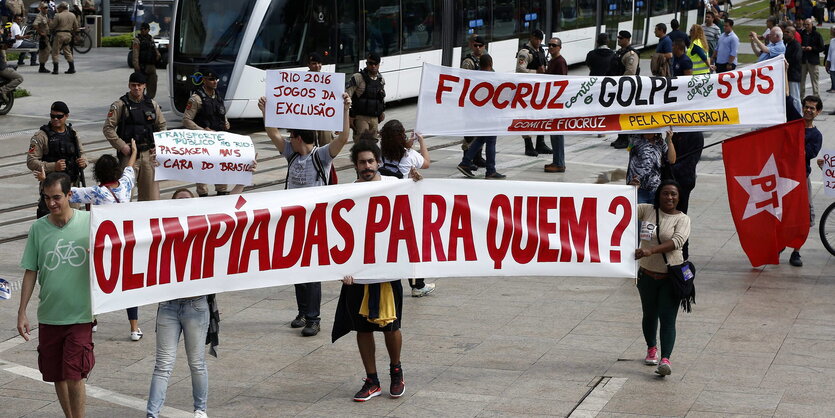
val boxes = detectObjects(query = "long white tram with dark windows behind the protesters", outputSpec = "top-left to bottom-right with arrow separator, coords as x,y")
168,0 -> 701,119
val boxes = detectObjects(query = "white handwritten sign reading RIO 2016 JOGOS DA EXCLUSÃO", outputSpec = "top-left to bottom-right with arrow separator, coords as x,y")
265,70 -> 345,131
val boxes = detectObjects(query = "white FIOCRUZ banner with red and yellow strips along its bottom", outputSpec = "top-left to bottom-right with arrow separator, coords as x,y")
415,56 -> 786,136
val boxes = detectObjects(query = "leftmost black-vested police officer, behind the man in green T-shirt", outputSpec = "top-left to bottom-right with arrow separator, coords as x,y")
26,102 -> 87,218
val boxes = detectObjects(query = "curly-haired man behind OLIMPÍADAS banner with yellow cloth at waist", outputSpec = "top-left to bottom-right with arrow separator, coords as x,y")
331,141 -> 421,402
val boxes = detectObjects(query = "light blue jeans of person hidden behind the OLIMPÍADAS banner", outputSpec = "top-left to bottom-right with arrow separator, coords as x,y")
147,296 -> 209,418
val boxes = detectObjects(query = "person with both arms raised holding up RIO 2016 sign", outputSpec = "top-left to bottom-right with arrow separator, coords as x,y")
258,92 -> 356,337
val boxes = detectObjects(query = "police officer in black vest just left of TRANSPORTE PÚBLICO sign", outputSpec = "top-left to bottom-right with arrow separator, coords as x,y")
102,73 -> 165,201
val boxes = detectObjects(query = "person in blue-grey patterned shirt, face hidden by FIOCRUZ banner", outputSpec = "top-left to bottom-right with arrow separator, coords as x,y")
626,128 -> 678,203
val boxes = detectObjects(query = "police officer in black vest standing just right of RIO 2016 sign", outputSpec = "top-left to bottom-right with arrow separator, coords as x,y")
345,52 -> 386,142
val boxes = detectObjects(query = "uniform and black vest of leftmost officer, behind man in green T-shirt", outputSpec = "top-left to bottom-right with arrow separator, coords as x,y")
26,104 -> 87,218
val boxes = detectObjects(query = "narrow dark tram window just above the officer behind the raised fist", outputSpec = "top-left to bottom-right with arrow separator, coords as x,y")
365,0 -> 400,57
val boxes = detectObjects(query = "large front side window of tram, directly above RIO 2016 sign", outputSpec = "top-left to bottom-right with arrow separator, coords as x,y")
247,0 -> 327,68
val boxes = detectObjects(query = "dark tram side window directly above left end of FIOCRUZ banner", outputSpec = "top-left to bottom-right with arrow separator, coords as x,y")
401,0 -> 441,51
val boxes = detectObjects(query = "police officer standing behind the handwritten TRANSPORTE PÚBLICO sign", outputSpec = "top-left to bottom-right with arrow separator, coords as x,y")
183,70 -> 229,197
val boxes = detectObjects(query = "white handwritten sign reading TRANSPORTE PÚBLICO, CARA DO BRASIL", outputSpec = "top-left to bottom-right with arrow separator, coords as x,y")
154,129 -> 255,185
